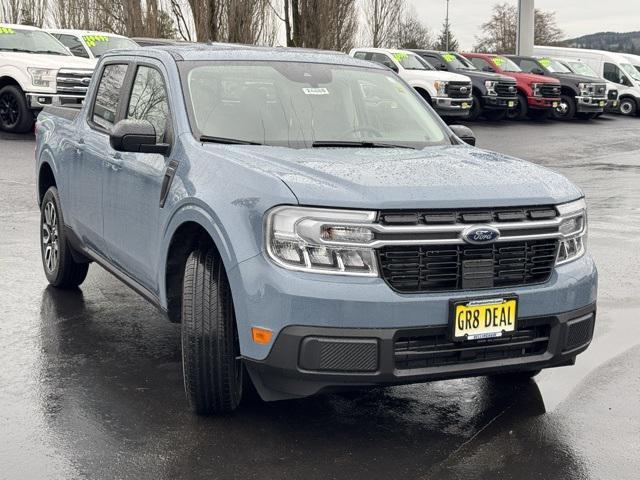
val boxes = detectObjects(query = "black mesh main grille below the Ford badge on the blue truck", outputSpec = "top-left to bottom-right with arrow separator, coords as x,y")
378,240 -> 558,293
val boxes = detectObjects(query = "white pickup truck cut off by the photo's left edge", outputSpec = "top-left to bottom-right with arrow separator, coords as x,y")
0,23 -> 96,133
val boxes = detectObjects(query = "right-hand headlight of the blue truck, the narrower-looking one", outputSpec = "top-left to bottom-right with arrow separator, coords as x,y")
556,199 -> 587,265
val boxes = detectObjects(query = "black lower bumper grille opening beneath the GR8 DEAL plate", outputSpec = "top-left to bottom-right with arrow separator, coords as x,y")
394,323 -> 551,370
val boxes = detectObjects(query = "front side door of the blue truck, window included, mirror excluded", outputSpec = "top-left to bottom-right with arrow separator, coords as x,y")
103,59 -> 173,294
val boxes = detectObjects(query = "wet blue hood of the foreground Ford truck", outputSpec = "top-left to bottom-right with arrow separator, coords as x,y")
204,144 -> 582,209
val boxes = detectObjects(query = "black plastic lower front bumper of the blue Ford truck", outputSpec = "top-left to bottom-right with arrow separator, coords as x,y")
245,304 -> 596,400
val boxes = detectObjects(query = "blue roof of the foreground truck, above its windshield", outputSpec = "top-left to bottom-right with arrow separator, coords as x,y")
102,43 -> 386,69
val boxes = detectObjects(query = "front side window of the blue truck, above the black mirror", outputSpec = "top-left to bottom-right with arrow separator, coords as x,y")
127,66 -> 169,143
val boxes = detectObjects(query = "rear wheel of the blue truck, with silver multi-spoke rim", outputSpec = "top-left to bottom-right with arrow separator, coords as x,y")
40,187 -> 89,289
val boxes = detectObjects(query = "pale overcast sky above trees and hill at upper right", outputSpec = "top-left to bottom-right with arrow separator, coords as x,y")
408,0 -> 640,50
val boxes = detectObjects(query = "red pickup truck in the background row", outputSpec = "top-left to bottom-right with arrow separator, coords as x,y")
463,53 -> 561,120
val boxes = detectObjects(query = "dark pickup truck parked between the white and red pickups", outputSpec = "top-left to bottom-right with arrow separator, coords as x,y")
412,50 -> 518,120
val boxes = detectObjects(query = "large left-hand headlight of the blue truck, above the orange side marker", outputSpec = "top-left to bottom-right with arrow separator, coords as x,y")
265,206 -> 378,277
